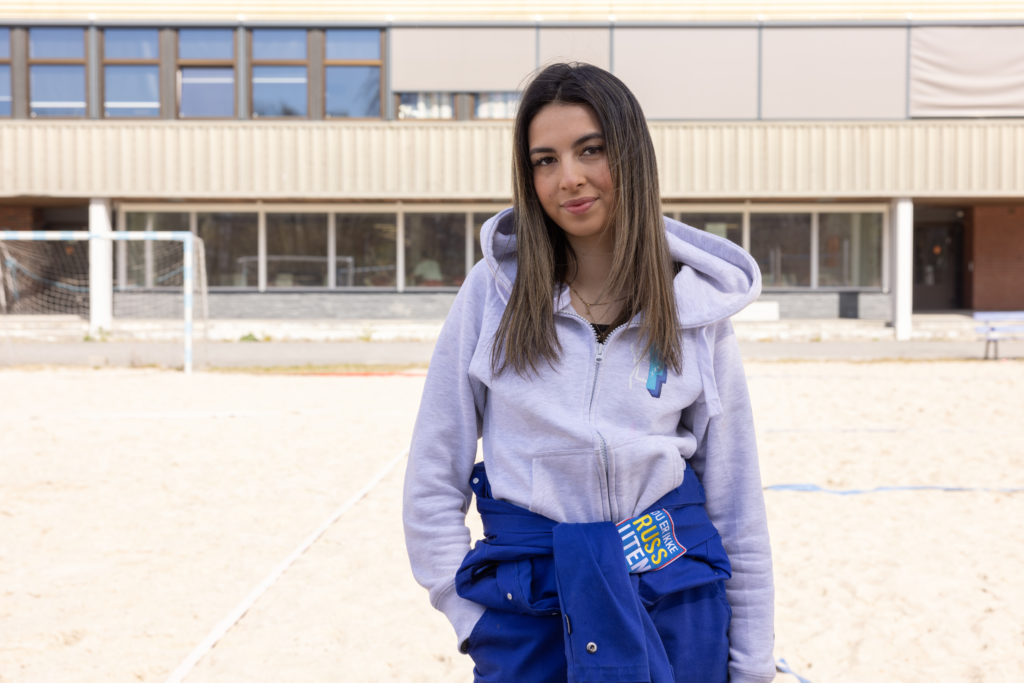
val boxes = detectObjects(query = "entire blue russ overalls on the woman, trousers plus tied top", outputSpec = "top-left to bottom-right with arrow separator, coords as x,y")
456,463 -> 731,683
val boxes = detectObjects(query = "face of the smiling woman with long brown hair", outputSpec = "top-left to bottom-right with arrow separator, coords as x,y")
527,103 -> 615,249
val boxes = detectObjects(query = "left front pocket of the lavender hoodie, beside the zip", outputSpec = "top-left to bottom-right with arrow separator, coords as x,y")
529,450 -> 608,522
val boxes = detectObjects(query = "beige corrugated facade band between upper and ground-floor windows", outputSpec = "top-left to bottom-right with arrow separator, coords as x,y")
0,120 -> 1024,201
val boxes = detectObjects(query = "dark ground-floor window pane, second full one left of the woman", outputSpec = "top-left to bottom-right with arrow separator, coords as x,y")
335,213 -> 398,287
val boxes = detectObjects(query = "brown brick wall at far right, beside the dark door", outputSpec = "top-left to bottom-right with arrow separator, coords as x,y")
972,204 -> 1024,310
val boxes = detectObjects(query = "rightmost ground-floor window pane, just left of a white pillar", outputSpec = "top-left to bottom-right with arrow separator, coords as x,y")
818,213 -> 882,287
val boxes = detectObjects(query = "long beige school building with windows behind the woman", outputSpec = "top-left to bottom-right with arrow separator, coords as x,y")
0,0 -> 1024,338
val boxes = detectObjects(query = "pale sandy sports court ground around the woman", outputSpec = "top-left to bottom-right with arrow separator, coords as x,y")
0,361 -> 1024,683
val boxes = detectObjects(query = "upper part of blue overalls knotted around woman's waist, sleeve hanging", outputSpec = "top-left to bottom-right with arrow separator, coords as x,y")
456,463 -> 730,681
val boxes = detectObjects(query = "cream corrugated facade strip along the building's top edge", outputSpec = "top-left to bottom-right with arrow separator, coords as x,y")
0,0 -> 1024,24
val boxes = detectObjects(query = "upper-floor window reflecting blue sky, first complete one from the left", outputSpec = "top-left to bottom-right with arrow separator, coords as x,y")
29,28 -> 85,117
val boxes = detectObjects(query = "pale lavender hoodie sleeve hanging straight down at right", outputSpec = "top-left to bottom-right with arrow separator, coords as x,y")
683,319 -> 775,683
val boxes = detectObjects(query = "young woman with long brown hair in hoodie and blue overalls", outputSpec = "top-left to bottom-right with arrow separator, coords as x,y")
403,65 -> 774,683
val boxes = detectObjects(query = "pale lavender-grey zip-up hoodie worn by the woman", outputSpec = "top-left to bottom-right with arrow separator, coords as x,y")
403,209 -> 775,683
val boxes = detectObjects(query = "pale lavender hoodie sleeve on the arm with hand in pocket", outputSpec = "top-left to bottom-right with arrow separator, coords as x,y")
402,266 -> 490,643
